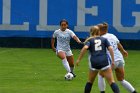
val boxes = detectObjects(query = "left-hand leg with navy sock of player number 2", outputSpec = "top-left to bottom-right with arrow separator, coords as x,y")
84,70 -> 98,93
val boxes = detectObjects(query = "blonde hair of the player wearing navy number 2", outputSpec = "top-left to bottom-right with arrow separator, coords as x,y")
84,26 -> 100,44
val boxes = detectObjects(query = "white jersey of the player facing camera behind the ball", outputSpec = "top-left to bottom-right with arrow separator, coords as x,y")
53,29 -> 75,51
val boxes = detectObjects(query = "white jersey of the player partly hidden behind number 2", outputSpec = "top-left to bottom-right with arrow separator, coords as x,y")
102,33 -> 124,62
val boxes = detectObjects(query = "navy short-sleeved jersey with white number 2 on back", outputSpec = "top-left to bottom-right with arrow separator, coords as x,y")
86,37 -> 110,69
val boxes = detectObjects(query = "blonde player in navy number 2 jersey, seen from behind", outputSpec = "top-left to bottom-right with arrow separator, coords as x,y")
76,26 -> 120,93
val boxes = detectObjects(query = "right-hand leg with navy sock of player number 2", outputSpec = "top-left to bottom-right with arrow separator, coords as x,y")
102,67 -> 120,93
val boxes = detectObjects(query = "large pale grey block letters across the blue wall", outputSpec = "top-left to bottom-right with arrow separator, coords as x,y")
0,0 -> 140,33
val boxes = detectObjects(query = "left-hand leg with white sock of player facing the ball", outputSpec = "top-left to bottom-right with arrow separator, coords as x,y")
57,51 -> 71,72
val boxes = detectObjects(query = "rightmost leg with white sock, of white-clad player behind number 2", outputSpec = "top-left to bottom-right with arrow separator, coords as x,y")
115,67 -> 137,93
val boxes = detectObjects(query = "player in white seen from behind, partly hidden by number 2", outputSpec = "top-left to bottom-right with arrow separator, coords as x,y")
98,23 -> 137,93
